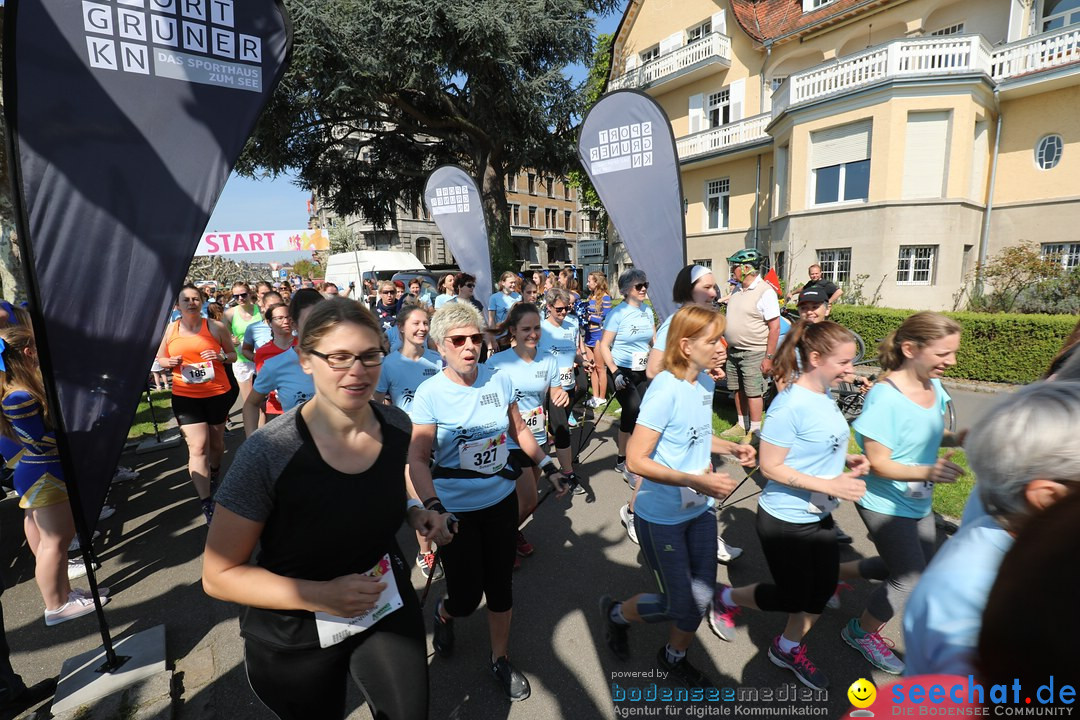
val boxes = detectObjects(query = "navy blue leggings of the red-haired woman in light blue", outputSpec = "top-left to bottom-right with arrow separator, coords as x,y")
634,510 -> 716,633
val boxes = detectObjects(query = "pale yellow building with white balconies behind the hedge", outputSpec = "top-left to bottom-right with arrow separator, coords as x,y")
608,0 -> 1080,310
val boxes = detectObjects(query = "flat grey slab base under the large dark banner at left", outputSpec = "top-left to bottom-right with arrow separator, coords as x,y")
52,625 -> 172,718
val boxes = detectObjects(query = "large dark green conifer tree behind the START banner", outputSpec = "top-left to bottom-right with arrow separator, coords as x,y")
239,0 -> 619,276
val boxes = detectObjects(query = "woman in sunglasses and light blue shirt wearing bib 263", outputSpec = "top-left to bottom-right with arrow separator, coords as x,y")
537,287 -> 586,494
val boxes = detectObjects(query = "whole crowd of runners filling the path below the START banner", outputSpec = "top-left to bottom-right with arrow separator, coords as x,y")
0,255 -> 1080,718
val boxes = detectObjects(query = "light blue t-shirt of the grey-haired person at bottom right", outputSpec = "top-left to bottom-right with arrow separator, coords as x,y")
904,515 -> 1010,677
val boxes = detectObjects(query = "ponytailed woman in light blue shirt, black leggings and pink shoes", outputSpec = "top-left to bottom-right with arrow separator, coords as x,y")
708,321 -> 869,690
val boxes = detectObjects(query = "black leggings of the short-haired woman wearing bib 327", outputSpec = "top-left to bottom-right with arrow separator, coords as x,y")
438,492 -> 517,617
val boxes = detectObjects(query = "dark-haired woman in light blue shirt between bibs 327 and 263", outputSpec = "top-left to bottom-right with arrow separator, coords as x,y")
485,302 -> 577,567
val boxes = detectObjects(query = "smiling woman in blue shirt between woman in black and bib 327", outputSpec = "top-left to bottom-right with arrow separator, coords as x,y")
375,304 -> 443,580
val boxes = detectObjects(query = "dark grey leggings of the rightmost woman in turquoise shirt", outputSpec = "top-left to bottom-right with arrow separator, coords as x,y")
855,504 -> 937,623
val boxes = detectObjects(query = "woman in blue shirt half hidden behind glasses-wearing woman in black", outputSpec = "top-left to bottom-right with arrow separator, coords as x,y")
244,287 -> 325,437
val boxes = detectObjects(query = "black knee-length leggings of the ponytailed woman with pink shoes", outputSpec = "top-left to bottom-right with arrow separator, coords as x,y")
754,507 -> 840,615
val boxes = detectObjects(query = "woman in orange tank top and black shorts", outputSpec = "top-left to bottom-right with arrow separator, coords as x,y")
157,284 -> 237,524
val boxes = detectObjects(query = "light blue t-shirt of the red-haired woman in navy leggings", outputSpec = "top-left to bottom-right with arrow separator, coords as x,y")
634,370 -> 716,525
